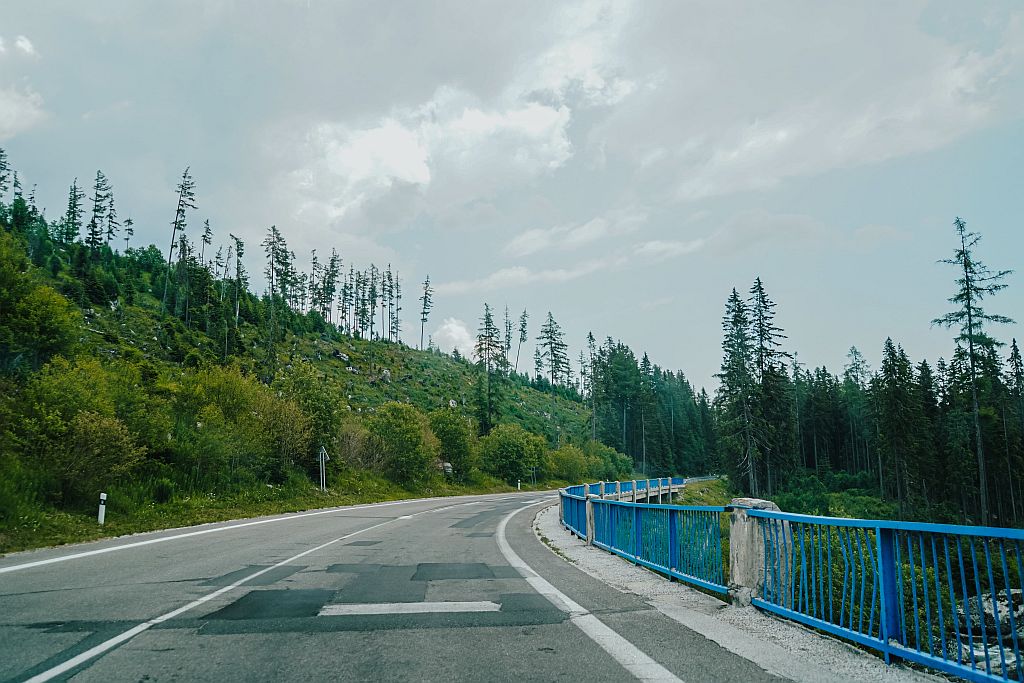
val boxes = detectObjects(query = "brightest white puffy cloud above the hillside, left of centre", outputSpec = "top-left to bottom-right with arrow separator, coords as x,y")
287,86 -> 572,227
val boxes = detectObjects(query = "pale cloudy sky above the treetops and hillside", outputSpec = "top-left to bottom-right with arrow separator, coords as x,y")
0,0 -> 1024,390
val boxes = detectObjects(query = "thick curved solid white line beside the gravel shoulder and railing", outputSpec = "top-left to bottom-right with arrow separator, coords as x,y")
496,505 -> 682,683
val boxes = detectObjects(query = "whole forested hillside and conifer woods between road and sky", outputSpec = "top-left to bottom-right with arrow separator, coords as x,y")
0,151 -> 1024,550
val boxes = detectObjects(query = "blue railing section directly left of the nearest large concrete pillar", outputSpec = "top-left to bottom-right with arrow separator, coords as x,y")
591,499 -> 728,593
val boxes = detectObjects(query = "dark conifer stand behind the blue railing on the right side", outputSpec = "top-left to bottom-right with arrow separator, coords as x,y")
713,227 -> 1024,525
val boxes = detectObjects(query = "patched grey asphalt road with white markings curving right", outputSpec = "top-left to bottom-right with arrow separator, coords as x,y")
0,494 -> 778,682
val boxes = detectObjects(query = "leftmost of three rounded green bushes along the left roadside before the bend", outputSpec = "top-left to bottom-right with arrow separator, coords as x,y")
367,401 -> 439,486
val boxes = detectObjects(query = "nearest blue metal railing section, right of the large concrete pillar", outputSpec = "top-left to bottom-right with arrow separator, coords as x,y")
749,510 -> 1024,681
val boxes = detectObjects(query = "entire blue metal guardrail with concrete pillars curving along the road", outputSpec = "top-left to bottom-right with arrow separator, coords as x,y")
561,477 -> 1024,682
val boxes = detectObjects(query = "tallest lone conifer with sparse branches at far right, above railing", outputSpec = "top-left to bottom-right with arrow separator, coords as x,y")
932,216 -> 1013,524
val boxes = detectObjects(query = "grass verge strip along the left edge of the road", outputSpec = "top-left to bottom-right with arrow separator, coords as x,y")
0,470 -> 550,555
